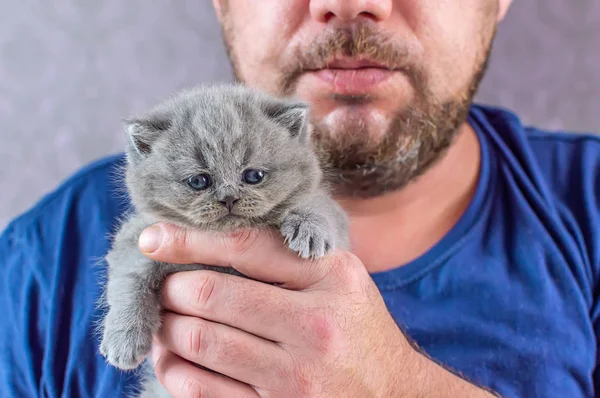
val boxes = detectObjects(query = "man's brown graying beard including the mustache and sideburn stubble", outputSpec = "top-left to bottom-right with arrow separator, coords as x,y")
218,21 -> 495,198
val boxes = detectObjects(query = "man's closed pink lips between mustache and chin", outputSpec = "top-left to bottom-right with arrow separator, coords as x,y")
307,58 -> 402,95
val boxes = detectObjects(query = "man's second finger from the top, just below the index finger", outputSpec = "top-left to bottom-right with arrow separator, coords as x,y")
162,271 -> 312,342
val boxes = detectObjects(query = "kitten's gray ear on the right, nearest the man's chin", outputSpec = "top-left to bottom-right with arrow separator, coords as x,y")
265,101 -> 310,142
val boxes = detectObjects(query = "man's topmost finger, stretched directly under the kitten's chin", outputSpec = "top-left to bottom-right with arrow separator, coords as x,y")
139,223 -> 328,289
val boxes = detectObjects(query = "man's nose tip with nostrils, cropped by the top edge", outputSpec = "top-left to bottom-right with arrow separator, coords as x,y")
310,0 -> 393,23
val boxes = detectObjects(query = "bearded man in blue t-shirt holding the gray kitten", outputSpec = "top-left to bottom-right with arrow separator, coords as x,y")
0,0 -> 600,397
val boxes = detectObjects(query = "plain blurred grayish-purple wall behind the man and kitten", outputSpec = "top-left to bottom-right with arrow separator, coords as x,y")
0,0 -> 600,229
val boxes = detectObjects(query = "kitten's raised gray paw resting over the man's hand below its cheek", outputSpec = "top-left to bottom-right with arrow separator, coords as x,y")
281,213 -> 334,258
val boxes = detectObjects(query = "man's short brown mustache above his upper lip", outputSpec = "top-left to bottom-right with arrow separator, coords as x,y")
280,22 -> 424,95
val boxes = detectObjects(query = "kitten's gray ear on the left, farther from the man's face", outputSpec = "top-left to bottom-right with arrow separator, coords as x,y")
123,115 -> 172,161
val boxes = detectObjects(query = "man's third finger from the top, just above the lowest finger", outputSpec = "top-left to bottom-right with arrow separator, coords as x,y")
157,312 -> 285,389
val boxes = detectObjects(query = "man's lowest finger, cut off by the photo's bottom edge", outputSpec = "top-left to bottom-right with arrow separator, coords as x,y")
152,346 -> 259,398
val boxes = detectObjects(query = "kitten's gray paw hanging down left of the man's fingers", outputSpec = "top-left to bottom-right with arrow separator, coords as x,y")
100,327 -> 152,370
